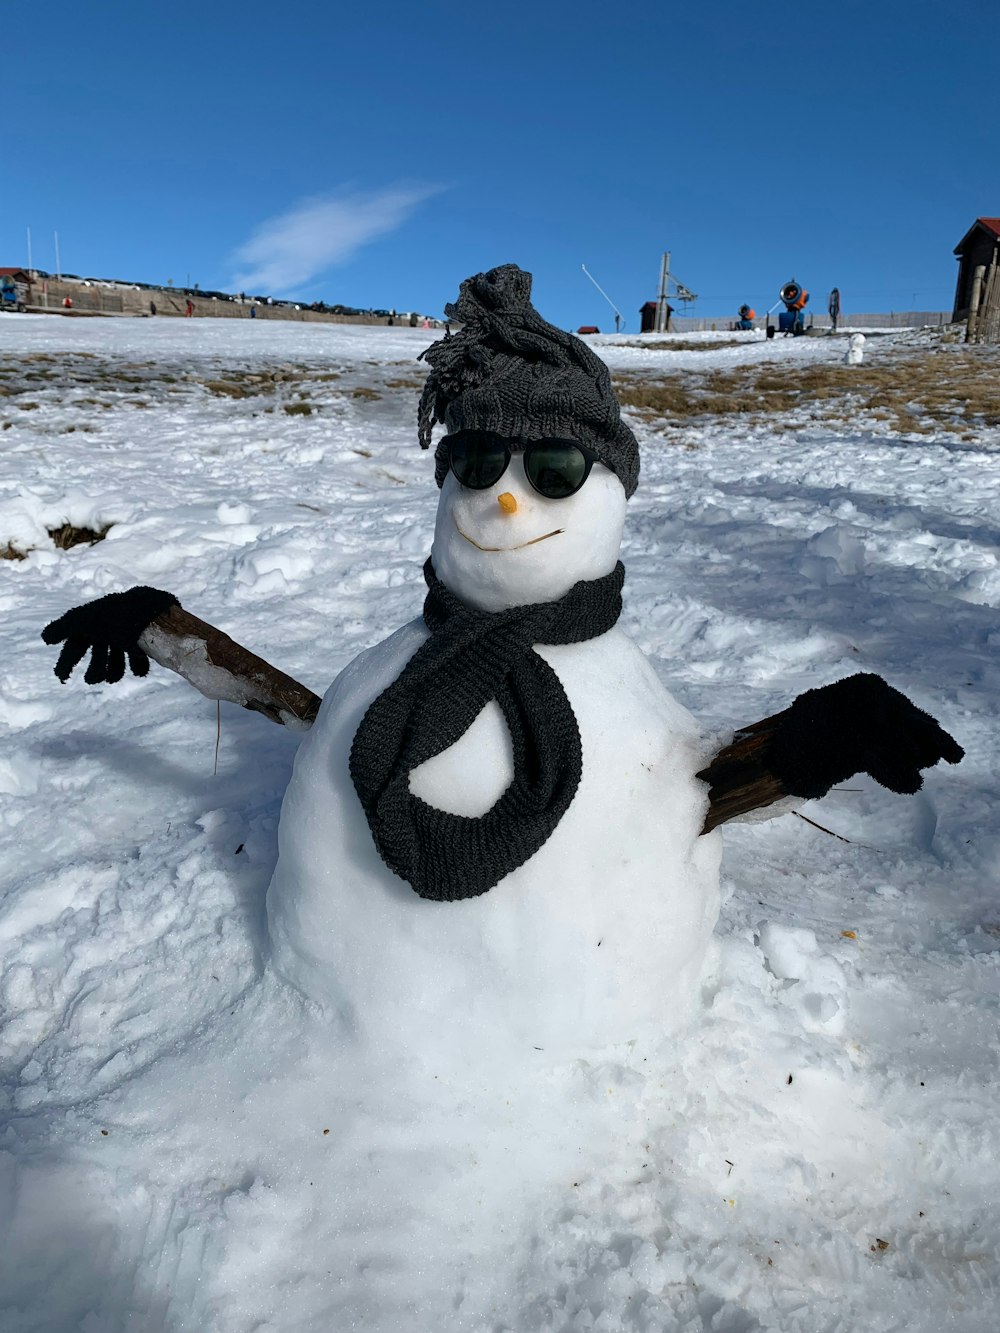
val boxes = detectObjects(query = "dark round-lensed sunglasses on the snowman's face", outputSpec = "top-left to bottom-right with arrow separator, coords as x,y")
441,431 -> 600,500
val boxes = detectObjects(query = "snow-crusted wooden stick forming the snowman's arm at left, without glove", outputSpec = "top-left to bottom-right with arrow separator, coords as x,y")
139,607 -> 321,729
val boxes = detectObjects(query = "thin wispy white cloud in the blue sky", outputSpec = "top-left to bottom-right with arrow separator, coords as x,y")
232,185 -> 440,295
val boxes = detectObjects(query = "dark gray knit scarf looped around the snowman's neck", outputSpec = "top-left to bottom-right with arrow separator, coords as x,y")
351,560 -> 625,902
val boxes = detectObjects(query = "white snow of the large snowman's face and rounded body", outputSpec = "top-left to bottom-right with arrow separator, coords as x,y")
268,457 -> 720,1064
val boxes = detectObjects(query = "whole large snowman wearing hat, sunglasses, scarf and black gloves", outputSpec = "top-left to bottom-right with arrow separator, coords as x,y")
43,265 -> 961,1068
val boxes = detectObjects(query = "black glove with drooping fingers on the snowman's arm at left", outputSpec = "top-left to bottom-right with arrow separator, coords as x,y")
41,588 -> 180,685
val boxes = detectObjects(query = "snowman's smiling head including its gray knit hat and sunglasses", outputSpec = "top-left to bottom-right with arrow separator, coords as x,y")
420,264 -> 639,611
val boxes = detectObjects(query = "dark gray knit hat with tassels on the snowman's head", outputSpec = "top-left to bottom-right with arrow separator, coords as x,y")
417,264 -> 639,496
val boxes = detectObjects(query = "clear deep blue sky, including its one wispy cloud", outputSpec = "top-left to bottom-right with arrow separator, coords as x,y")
0,0 -> 1000,329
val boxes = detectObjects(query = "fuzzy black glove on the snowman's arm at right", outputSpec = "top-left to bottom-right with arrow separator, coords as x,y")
768,674 -> 965,800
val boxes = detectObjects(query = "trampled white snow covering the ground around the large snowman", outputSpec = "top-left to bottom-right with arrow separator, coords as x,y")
0,316 -> 1000,1333
